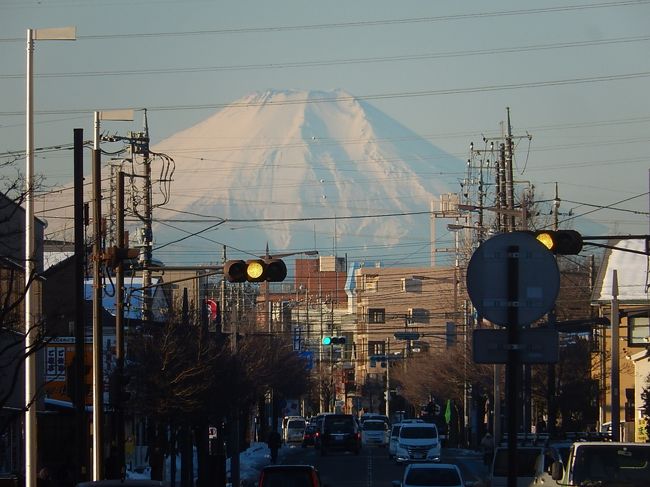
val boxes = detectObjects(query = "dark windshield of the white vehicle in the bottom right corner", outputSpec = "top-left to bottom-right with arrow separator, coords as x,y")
573,444 -> 650,486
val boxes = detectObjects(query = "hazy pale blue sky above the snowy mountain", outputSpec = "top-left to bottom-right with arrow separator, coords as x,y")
0,0 -> 650,248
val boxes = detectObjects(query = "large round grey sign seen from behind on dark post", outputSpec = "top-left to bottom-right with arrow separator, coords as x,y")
467,232 -> 560,326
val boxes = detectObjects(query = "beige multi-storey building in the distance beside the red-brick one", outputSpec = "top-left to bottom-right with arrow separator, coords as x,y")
346,267 -> 458,409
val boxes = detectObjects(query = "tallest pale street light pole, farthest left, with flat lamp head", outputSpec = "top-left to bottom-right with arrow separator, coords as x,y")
25,27 -> 76,487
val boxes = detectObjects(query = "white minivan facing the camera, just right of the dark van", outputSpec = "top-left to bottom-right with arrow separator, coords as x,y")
395,423 -> 441,463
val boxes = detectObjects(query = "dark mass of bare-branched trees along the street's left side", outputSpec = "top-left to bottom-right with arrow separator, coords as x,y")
126,313 -> 309,485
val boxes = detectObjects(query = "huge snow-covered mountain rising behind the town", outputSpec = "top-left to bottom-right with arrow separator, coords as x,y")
153,90 -> 465,266
